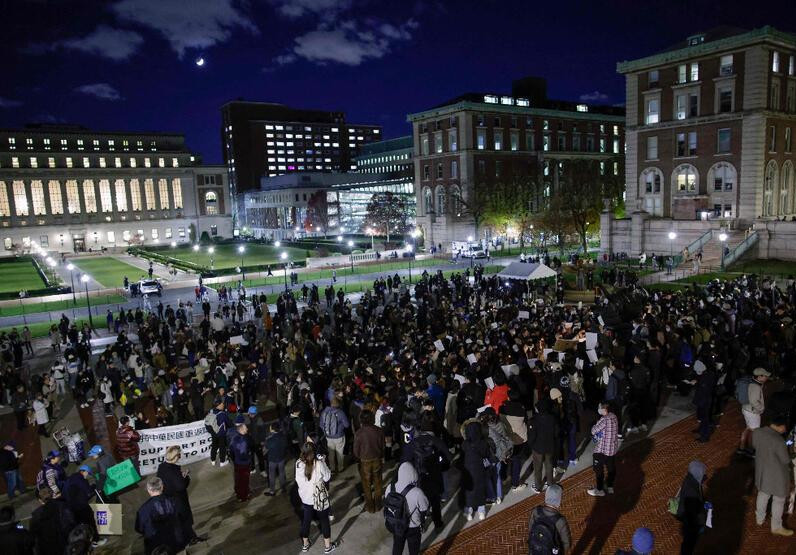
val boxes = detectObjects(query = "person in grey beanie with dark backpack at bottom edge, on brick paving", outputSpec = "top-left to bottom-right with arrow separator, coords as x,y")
528,484 -> 572,555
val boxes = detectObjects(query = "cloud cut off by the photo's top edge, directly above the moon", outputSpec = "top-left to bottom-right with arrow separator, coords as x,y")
111,0 -> 259,58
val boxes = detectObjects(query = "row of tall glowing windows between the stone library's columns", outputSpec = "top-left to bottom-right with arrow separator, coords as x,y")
0,178 -> 185,218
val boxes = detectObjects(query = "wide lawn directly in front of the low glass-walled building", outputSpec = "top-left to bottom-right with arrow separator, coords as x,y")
143,243 -> 307,269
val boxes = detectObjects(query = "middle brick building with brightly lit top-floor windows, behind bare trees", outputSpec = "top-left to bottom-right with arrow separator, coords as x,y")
408,77 -> 625,245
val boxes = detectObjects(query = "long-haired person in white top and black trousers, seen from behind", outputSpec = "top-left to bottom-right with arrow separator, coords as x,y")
296,441 -> 337,553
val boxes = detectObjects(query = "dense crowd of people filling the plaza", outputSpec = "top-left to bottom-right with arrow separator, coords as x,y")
4,258 -> 796,553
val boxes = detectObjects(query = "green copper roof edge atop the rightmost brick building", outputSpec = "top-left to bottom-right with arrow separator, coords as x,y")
616,25 -> 796,73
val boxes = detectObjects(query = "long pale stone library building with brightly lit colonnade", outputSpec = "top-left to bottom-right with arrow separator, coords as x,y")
0,125 -> 232,256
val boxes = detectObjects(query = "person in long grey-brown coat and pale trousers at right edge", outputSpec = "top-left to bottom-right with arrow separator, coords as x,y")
752,416 -> 793,537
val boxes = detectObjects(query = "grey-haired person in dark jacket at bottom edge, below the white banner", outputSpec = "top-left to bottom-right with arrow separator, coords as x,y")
135,477 -> 188,555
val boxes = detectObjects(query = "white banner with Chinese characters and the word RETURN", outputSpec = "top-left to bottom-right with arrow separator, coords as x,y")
138,420 -> 212,476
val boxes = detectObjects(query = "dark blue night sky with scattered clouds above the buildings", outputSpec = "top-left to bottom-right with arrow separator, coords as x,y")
0,0 -> 796,163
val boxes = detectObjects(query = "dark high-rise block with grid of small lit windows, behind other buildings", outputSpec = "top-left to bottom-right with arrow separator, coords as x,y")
221,100 -> 381,224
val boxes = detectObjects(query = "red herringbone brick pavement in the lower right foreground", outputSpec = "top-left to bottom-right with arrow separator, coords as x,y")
425,402 -> 796,555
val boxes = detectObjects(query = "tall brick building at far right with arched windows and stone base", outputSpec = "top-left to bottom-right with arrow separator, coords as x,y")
602,27 -> 796,257
